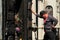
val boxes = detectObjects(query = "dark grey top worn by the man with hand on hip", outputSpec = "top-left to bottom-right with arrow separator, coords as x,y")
36,15 -> 58,31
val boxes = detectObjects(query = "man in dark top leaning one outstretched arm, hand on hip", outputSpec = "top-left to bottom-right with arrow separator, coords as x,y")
31,4 -> 58,40
